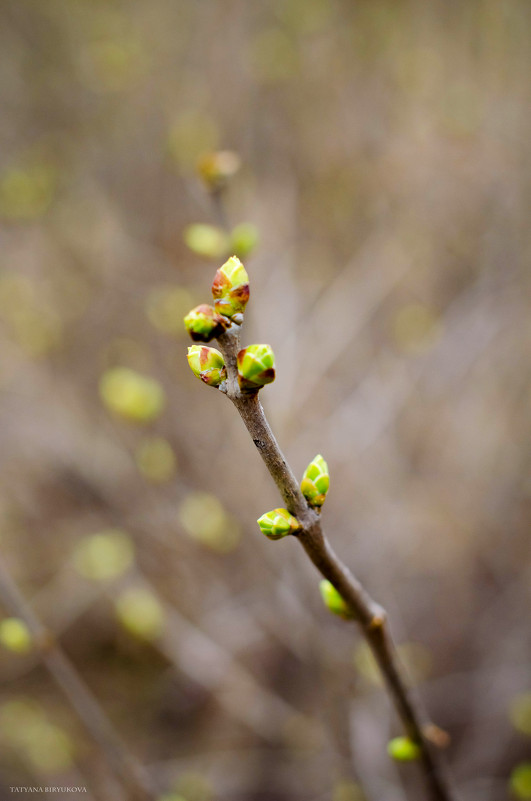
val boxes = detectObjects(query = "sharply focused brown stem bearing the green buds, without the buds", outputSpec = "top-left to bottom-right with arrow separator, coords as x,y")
218,326 -> 455,801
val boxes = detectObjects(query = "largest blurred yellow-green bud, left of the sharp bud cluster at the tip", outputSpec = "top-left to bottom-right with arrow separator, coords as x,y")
100,367 -> 165,423
